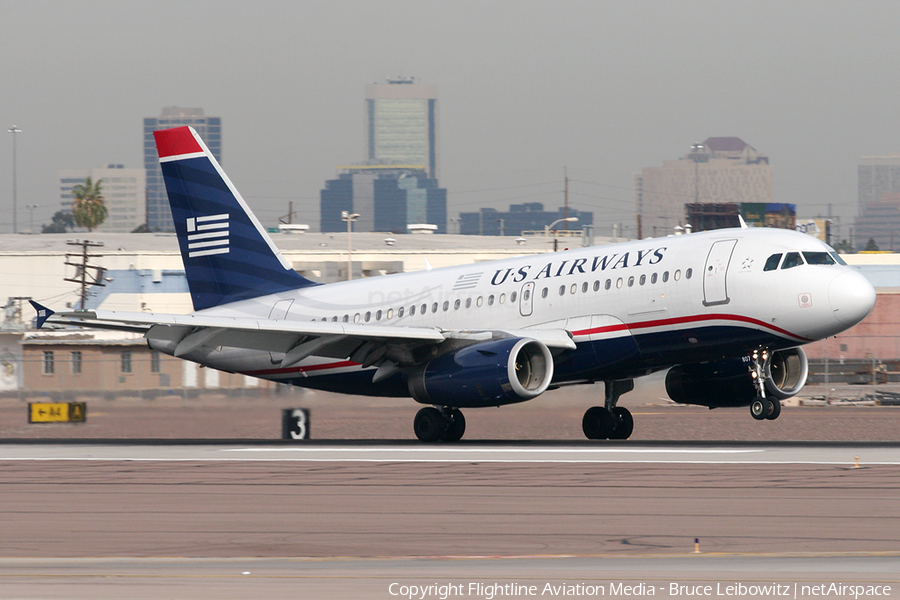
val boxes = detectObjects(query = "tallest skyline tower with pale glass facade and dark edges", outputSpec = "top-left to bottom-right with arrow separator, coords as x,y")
366,77 -> 438,179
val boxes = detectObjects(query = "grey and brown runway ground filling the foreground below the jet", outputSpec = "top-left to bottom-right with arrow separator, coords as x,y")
0,442 -> 900,598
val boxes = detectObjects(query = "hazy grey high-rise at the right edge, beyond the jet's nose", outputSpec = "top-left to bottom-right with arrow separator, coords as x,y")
854,154 -> 900,251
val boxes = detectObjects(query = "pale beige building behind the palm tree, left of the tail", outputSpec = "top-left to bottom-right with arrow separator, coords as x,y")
59,165 -> 147,233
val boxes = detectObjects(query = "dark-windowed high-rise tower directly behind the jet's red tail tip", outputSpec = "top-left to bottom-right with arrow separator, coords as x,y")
144,106 -> 222,231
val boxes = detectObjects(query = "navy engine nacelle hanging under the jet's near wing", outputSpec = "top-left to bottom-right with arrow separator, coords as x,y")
409,338 -> 553,408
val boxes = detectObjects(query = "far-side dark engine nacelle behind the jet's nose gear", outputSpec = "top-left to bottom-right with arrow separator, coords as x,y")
666,348 -> 809,407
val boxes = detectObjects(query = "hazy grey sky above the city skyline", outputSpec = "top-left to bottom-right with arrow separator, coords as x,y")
0,0 -> 900,239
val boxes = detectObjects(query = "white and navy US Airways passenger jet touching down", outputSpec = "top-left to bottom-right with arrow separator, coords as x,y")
29,127 -> 875,442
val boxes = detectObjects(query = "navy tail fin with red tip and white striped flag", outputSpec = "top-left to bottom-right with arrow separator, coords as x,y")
153,127 -> 315,310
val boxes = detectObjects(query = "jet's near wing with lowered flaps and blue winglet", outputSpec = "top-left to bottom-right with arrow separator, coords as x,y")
31,301 -> 575,367
